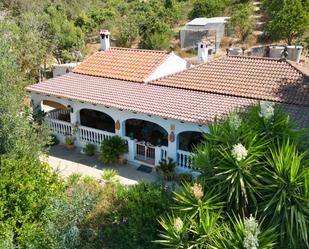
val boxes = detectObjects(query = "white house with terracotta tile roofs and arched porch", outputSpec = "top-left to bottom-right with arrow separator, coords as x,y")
27,31 -> 309,171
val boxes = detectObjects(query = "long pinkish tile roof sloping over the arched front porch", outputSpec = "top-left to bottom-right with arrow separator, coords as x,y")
27,73 -> 309,125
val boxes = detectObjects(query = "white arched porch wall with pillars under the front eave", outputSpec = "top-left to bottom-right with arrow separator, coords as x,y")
31,93 -> 209,167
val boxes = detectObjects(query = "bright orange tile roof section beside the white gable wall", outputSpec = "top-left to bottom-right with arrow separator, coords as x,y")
73,48 -> 170,82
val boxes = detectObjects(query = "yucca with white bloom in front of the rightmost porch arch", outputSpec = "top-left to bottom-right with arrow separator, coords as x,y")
194,130 -> 268,212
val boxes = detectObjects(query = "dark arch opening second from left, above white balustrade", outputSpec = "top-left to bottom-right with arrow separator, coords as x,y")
80,109 -> 115,133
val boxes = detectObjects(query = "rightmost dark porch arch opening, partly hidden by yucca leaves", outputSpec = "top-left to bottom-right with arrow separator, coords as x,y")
178,131 -> 203,152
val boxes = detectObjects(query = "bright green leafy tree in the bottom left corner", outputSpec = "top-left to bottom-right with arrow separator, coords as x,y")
0,157 -> 61,249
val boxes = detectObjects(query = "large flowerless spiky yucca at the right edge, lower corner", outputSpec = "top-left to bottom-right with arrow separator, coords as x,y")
260,140 -> 309,248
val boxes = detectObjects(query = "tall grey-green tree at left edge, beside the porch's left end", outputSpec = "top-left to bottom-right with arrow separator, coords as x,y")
0,35 -> 47,157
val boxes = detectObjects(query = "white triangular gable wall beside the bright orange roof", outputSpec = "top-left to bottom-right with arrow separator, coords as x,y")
145,53 -> 191,82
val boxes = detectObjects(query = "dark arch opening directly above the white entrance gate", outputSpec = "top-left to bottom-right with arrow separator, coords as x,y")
125,119 -> 168,146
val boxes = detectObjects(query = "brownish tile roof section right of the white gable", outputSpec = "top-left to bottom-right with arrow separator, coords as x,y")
150,56 -> 309,105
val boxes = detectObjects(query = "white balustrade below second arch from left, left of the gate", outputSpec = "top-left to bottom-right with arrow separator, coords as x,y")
78,126 -> 115,145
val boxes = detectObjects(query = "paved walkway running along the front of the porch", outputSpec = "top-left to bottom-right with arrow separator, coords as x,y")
48,145 -> 159,185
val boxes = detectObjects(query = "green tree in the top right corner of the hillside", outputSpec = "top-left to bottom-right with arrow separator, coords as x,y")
267,0 -> 309,44
